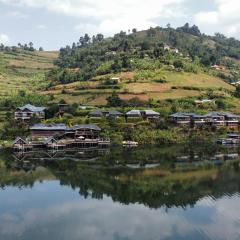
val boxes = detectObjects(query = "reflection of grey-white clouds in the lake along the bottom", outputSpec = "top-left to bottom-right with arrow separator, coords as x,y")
0,195 -> 240,240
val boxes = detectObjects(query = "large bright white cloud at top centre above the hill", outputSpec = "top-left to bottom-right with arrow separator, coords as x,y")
0,0 -> 186,35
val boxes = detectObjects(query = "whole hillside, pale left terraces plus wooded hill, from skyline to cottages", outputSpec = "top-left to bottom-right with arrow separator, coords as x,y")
0,24 -> 240,112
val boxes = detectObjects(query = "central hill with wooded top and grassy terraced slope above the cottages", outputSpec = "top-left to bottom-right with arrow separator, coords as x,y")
44,24 -> 240,105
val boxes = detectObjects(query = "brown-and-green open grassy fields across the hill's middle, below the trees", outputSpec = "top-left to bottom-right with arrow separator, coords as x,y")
45,71 -> 234,104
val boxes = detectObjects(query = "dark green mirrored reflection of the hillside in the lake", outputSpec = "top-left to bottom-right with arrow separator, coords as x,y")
1,144 -> 240,208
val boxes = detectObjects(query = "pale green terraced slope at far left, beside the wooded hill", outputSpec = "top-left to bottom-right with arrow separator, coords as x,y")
0,49 -> 58,98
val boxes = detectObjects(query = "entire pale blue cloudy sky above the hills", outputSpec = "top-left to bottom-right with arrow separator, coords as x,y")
0,0 -> 240,50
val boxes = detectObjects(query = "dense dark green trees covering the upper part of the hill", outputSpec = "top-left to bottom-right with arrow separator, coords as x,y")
48,24 -> 240,84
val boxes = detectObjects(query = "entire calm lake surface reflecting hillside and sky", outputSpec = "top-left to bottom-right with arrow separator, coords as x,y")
0,144 -> 240,240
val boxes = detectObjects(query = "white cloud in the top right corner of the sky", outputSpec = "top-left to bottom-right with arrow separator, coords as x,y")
194,0 -> 240,38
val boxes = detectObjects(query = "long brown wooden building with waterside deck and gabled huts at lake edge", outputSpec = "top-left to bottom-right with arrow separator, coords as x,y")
13,124 -> 110,151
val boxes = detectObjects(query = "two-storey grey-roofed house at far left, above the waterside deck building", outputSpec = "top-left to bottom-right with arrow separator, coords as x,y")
14,104 -> 45,121
